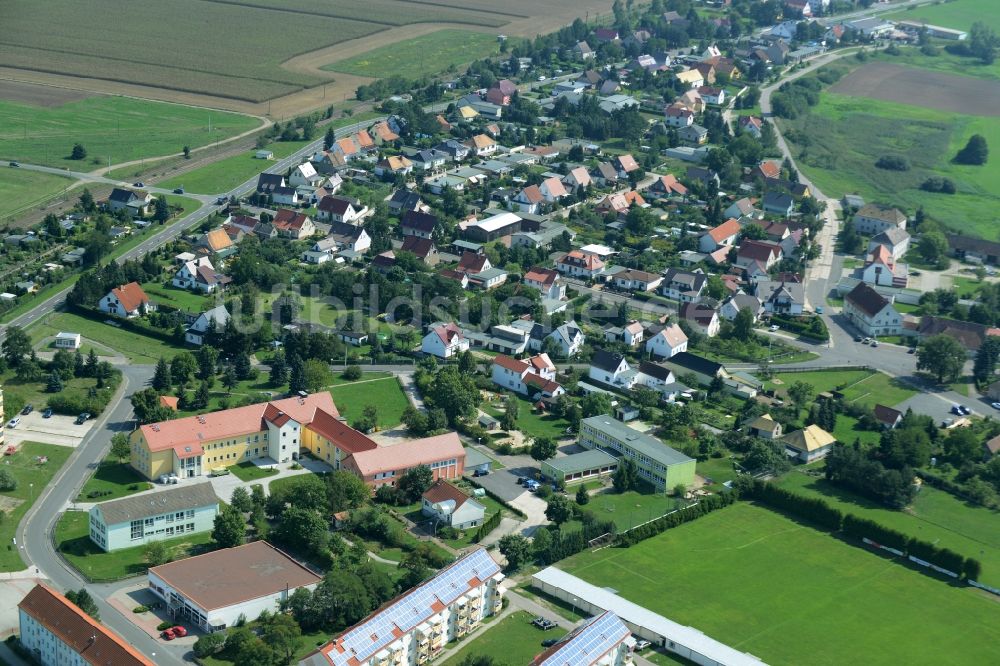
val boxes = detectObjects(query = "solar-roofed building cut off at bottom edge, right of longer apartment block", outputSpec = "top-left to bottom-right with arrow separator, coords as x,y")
531,611 -> 635,666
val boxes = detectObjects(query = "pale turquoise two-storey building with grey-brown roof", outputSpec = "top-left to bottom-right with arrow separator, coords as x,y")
90,481 -> 219,552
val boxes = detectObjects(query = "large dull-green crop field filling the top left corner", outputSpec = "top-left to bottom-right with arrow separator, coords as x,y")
0,0 -> 511,102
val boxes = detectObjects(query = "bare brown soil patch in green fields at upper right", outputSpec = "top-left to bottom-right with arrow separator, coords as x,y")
830,62 -> 1000,116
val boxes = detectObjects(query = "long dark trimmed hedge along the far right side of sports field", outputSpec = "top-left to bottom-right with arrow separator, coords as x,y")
740,479 -> 982,580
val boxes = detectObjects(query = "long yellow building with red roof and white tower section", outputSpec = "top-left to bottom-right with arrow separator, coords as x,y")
130,392 -> 376,479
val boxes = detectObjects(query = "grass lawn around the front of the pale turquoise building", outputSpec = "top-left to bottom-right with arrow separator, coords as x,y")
55,511 -> 212,583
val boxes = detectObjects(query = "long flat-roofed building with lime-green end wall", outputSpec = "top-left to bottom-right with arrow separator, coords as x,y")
577,414 -> 695,492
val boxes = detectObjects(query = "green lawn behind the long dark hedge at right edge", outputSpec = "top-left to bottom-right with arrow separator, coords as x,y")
776,464 -> 1000,587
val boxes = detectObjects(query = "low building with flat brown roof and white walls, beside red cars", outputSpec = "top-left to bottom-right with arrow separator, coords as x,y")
146,541 -> 320,631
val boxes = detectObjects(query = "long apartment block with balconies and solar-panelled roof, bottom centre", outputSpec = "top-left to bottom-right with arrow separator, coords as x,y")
299,548 -> 504,666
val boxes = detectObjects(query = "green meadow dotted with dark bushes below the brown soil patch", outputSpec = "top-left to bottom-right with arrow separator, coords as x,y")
780,62 -> 1000,240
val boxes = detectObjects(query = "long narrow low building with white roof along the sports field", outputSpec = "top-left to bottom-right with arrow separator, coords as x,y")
531,567 -> 764,666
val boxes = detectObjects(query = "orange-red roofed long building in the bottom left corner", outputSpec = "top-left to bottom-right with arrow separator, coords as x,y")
17,583 -> 154,666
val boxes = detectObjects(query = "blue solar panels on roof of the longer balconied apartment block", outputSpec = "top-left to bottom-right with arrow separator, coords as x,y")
329,548 -> 500,666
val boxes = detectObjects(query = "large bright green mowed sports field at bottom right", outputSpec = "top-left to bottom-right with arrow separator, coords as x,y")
559,502 -> 1000,666
